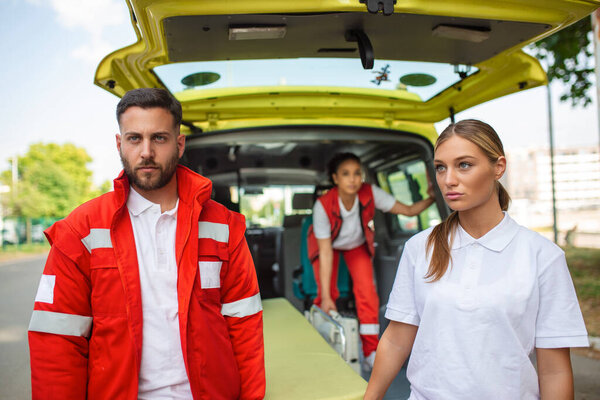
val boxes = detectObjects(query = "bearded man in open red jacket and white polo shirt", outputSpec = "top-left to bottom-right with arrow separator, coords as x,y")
29,89 -> 265,400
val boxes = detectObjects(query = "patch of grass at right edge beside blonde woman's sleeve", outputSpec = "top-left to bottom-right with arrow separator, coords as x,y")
564,247 -> 600,336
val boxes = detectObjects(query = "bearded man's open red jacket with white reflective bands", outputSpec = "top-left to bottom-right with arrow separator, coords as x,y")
29,166 -> 265,400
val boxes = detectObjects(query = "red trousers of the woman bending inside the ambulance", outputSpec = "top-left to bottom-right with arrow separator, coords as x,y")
313,244 -> 379,357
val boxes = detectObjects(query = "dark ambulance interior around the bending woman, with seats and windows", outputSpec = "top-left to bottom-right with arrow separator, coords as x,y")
183,125 -> 447,328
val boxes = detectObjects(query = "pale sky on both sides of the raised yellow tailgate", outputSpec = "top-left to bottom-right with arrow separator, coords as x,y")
0,0 -> 599,184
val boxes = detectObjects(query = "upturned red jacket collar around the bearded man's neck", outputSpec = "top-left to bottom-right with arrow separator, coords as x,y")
113,165 -> 212,212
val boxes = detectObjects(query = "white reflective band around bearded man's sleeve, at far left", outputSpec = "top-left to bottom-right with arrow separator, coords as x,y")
29,310 -> 92,337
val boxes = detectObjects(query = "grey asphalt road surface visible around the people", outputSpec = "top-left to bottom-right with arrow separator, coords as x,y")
0,256 -> 600,400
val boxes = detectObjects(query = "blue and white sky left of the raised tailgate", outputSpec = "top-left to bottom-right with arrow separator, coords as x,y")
0,0 -> 136,184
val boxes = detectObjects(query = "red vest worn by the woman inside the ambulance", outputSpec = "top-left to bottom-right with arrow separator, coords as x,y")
307,183 -> 375,263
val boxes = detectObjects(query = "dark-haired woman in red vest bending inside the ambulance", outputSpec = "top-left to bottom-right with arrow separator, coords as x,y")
308,153 -> 434,369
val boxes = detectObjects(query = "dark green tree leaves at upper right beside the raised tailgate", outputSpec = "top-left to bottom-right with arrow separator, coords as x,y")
533,16 -> 594,107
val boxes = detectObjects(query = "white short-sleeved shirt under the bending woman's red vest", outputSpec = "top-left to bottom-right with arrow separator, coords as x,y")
313,185 -> 396,250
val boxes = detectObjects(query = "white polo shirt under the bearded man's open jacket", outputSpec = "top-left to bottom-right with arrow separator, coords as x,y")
127,188 -> 192,399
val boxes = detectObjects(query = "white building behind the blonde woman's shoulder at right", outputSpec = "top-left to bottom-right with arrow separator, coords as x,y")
505,146 -> 600,241
